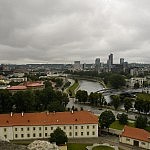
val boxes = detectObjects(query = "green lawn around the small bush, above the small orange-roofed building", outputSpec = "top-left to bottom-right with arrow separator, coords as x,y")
110,120 -> 135,130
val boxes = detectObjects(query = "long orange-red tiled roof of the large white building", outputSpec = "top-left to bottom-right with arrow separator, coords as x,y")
0,111 -> 98,126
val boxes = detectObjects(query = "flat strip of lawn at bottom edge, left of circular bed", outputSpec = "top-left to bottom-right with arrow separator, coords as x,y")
67,143 -> 90,150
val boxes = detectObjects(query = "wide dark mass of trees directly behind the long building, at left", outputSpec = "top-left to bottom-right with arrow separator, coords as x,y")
0,82 -> 69,113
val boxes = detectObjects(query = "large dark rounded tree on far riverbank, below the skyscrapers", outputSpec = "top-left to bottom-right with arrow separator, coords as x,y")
110,74 -> 125,89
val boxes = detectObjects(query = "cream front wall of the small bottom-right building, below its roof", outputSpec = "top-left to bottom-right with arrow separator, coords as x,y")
119,137 -> 150,149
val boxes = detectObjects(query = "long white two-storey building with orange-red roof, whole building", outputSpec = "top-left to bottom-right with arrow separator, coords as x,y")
0,111 -> 98,140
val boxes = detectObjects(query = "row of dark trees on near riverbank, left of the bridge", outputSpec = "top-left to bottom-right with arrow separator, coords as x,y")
76,90 -> 107,106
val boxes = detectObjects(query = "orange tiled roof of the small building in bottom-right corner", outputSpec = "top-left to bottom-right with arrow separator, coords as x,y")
121,126 -> 150,142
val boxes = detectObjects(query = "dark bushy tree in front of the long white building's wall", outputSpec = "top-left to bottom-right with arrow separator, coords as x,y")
49,127 -> 68,145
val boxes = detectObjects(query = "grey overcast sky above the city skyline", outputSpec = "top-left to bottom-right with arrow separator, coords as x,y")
0,0 -> 150,64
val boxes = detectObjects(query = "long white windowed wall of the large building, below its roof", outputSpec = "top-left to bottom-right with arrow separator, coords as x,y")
0,124 -> 98,140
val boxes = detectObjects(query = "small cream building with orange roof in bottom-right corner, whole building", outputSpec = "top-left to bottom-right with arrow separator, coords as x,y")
119,126 -> 150,149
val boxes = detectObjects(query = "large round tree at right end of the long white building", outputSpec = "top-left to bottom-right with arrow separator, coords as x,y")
99,110 -> 115,130
